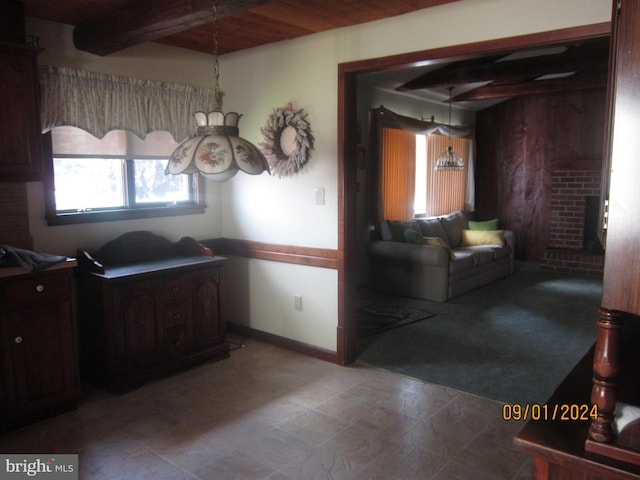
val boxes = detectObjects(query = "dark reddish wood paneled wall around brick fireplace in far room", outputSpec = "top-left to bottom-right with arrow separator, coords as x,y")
475,89 -> 605,261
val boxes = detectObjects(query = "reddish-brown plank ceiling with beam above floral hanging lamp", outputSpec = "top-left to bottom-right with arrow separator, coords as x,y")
23,0 -> 457,55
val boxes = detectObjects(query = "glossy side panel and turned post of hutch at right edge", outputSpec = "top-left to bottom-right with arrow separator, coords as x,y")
586,0 -> 640,465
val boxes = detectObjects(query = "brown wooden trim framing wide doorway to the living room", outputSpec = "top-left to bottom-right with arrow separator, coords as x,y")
337,22 -> 611,365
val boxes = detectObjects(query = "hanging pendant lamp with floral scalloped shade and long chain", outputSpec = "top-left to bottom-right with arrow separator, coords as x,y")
165,2 -> 271,182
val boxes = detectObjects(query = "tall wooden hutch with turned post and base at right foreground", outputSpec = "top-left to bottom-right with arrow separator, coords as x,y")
516,0 -> 640,480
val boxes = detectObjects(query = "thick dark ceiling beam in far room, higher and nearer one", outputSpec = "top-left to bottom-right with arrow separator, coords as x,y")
397,42 -> 609,91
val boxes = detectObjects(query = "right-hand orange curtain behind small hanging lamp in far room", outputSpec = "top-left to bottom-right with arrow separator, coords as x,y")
425,134 -> 470,217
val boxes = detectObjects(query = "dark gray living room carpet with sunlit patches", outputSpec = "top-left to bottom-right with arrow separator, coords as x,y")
358,263 -> 602,403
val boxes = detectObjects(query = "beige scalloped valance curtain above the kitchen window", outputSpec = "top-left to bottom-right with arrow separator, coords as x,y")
40,65 -> 214,142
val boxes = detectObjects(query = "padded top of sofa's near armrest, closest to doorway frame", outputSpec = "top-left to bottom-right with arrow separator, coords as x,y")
367,240 -> 449,267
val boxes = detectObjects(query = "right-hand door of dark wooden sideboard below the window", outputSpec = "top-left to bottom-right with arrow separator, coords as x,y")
192,267 -> 224,346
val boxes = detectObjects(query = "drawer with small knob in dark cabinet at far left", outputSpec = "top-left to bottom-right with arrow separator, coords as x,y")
0,274 -> 70,305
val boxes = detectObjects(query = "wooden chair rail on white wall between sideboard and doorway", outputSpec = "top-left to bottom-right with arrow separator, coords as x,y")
202,238 -> 338,270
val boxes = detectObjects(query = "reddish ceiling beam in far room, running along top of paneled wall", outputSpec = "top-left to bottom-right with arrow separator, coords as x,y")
447,71 -> 607,102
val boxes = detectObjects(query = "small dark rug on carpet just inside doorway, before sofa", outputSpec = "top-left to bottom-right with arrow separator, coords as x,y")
357,302 -> 433,338
